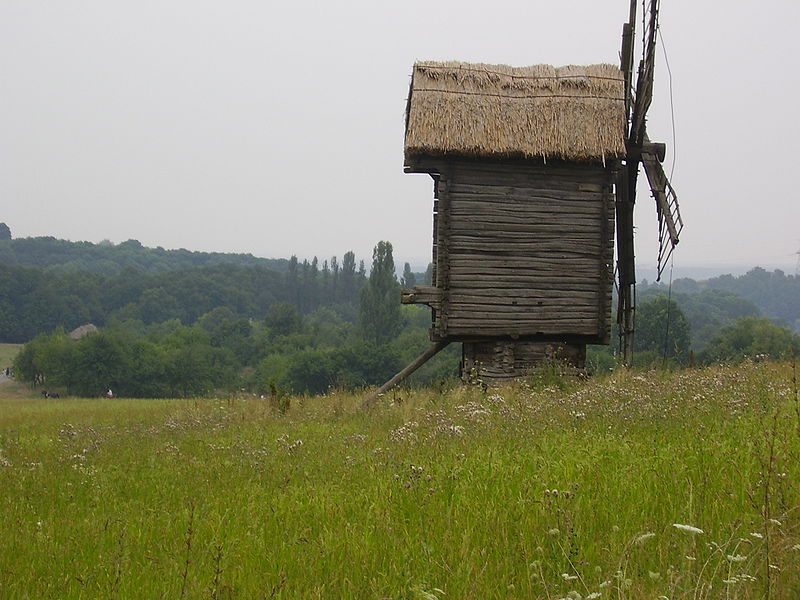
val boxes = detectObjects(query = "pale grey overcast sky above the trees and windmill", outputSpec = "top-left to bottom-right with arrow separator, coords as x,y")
0,0 -> 800,271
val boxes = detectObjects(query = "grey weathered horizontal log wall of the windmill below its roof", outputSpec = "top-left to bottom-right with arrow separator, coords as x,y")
407,160 -> 614,344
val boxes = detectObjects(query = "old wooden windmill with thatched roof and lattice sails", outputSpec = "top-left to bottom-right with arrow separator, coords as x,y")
364,0 -> 682,404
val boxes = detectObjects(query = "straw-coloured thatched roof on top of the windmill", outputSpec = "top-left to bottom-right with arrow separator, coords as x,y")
405,62 -> 626,161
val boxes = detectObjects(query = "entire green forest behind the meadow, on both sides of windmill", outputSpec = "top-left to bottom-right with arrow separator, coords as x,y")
0,227 -> 800,397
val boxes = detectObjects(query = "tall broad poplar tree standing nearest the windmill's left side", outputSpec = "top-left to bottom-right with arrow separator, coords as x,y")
360,242 -> 401,345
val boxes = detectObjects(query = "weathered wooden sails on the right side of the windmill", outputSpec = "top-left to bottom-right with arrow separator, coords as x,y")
616,0 -> 683,364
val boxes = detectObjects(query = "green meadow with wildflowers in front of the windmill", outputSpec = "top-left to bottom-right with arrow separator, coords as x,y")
0,363 -> 800,600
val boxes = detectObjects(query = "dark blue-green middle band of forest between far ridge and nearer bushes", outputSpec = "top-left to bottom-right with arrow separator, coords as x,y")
0,252 -> 378,343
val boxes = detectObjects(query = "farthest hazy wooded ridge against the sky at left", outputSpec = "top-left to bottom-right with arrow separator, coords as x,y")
0,237 -> 289,275
